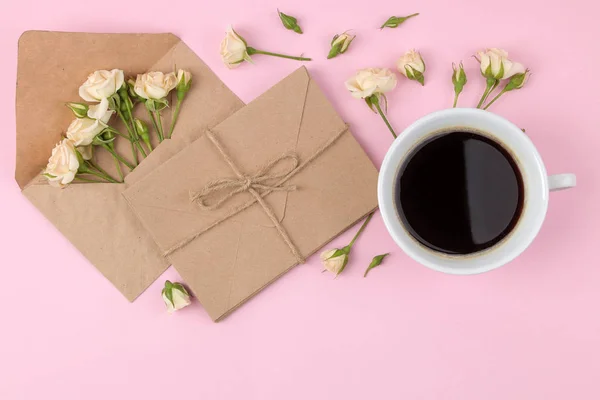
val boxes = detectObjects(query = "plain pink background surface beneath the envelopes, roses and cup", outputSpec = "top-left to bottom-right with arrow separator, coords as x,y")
0,0 -> 600,400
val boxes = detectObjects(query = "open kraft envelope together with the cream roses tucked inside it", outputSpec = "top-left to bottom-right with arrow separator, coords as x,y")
16,31 -> 243,300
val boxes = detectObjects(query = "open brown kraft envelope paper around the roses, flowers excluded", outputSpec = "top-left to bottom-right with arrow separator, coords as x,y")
15,31 -> 243,301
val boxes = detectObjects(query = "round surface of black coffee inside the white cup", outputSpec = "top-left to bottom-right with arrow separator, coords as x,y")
394,131 -> 524,254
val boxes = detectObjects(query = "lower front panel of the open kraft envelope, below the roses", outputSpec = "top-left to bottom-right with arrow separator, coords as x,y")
23,182 -> 168,301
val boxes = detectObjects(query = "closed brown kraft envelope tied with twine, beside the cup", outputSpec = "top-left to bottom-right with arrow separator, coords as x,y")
124,68 -> 377,320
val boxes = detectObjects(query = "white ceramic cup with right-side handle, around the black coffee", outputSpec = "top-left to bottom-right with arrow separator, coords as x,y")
377,108 -> 576,275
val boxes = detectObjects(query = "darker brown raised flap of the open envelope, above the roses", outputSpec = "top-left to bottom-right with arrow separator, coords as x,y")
15,31 -> 180,188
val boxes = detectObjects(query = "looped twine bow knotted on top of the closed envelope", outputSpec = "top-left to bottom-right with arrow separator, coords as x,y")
190,153 -> 300,210
